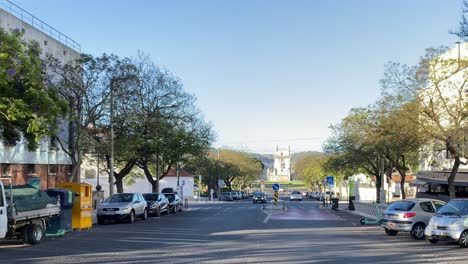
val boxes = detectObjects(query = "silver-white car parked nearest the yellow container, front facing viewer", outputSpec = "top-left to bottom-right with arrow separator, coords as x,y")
96,193 -> 148,224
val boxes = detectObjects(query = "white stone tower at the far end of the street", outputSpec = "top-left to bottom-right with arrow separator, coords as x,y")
268,146 -> 291,181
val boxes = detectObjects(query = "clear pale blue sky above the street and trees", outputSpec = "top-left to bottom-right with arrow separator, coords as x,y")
7,0 -> 462,153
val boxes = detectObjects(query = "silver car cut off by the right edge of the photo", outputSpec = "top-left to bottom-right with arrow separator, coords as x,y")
424,198 -> 468,248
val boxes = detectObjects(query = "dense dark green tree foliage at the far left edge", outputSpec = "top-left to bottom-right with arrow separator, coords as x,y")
0,28 -> 67,150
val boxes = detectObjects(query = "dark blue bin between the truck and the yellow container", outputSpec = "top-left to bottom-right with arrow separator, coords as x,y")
45,189 -> 73,234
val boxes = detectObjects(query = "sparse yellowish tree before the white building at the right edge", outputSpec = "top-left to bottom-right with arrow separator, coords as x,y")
384,48 -> 468,198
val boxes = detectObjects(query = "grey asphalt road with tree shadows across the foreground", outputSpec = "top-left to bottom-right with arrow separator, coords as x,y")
0,197 -> 468,263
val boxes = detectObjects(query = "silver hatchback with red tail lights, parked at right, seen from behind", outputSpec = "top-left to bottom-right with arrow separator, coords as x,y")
381,198 -> 445,239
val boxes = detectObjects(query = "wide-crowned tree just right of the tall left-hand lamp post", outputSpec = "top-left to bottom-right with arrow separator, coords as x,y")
132,54 -> 213,192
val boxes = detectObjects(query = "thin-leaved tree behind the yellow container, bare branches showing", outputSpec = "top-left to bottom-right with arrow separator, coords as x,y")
46,54 -> 124,181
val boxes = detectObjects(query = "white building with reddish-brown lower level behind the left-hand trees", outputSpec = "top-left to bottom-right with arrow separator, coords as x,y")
0,2 -> 80,189
